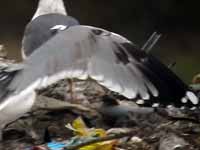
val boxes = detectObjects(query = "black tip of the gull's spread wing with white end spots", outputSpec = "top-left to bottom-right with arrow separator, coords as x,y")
118,43 -> 199,109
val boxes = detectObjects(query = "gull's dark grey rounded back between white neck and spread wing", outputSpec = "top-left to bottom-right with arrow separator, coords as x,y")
22,14 -> 79,57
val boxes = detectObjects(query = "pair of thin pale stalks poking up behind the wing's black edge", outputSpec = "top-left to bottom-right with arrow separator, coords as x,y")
141,32 -> 161,53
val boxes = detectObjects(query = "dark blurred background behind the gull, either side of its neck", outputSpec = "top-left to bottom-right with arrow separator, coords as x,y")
0,0 -> 200,83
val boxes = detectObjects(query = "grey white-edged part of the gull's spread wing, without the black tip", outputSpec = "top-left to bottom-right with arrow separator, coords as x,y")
10,26 -> 158,99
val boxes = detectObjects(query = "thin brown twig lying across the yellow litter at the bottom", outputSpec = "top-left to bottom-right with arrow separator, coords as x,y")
64,129 -> 138,150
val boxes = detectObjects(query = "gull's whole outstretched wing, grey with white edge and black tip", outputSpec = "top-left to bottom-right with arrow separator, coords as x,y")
10,26 -> 198,106
